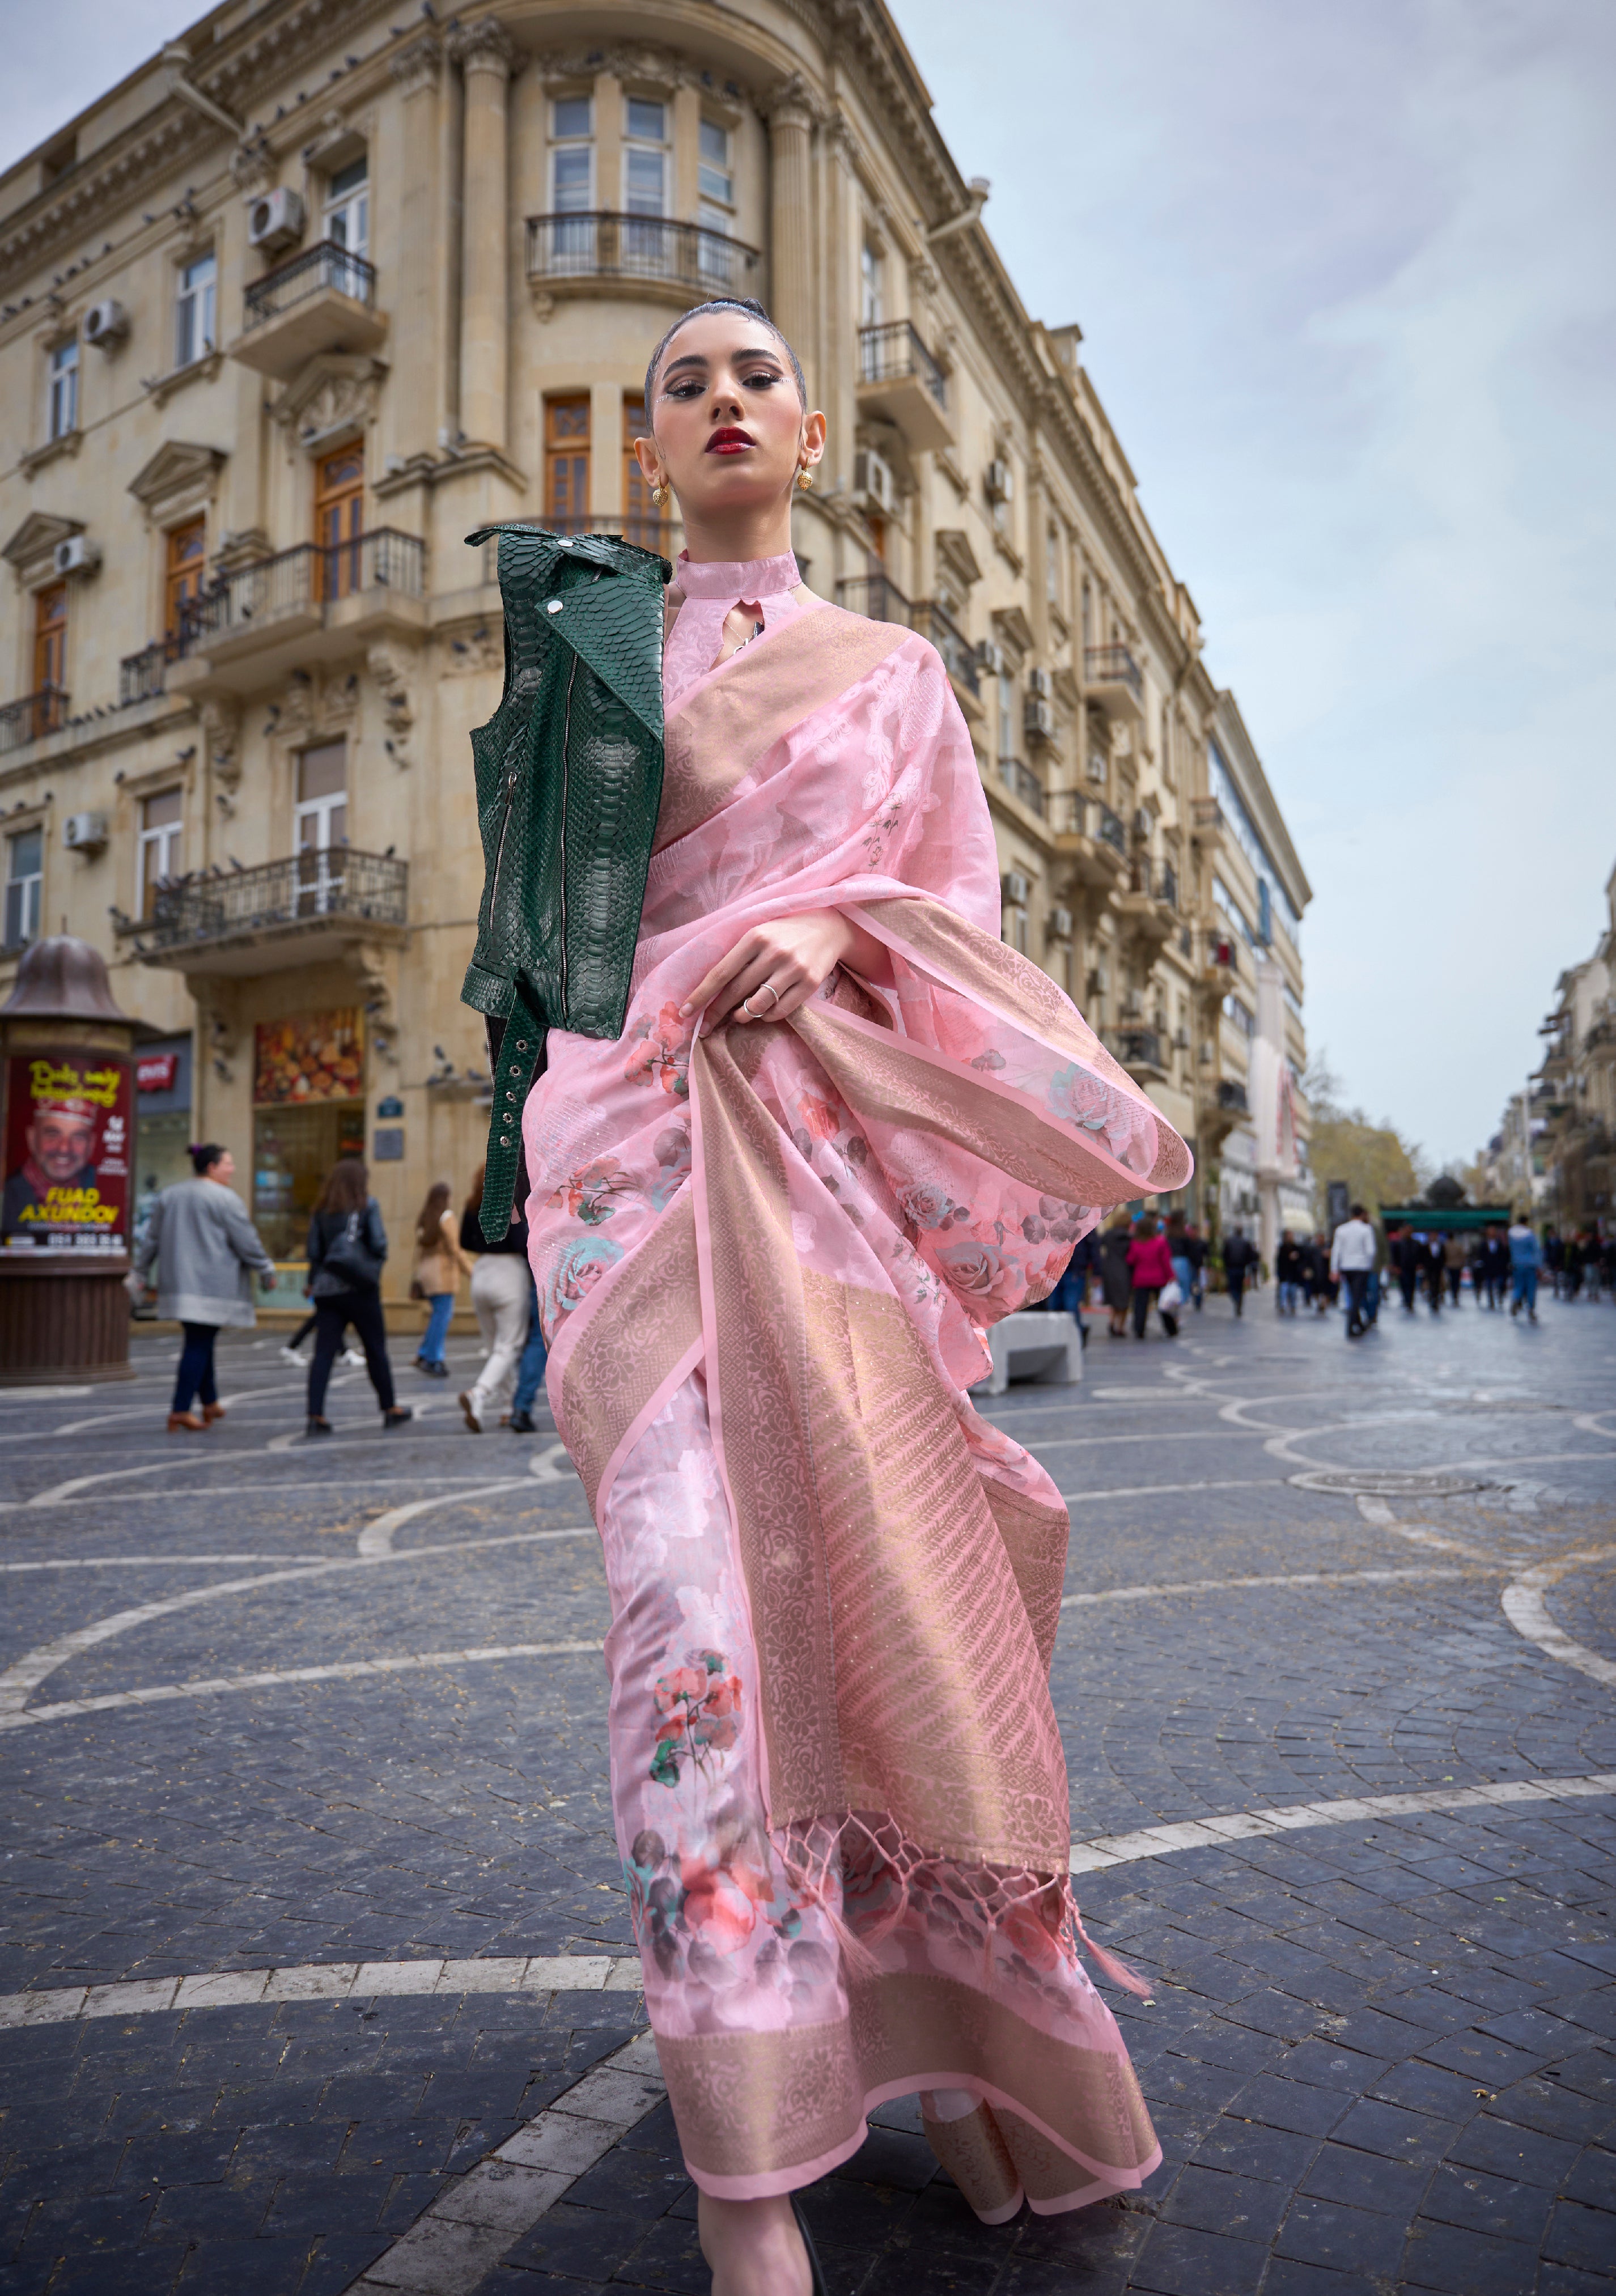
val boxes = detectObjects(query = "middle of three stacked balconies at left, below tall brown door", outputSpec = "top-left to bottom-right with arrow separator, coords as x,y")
168,526 -> 427,693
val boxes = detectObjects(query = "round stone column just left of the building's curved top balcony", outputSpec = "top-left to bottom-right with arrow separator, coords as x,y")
450,16 -> 519,450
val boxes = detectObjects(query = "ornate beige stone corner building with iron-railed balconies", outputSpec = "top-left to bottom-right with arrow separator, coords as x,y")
0,0 -> 1308,1276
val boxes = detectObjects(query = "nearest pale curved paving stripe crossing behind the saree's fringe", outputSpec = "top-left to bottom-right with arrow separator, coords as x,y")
0,1770 -> 1616,2030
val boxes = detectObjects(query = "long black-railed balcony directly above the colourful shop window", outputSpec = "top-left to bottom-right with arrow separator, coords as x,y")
135,845 -> 409,978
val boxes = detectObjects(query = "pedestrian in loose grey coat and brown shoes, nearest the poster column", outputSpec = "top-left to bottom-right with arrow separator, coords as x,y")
129,1141 -> 275,1435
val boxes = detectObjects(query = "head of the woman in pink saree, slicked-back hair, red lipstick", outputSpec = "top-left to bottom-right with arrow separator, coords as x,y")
634,310 -> 824,521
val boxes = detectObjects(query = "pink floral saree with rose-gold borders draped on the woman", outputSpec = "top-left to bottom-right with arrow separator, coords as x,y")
523,604 -> 1191,2211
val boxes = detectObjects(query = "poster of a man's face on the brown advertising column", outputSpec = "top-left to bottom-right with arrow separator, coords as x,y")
0,1047 -> 133,1251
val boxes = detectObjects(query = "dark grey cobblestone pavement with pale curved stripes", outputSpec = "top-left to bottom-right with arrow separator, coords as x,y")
0,1295 -> 1616,2296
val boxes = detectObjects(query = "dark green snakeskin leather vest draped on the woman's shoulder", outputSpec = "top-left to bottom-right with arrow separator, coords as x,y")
461,526 -> 673,1242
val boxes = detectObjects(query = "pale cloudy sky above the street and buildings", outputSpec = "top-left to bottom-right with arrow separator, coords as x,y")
0,0 -> 1616,1162
